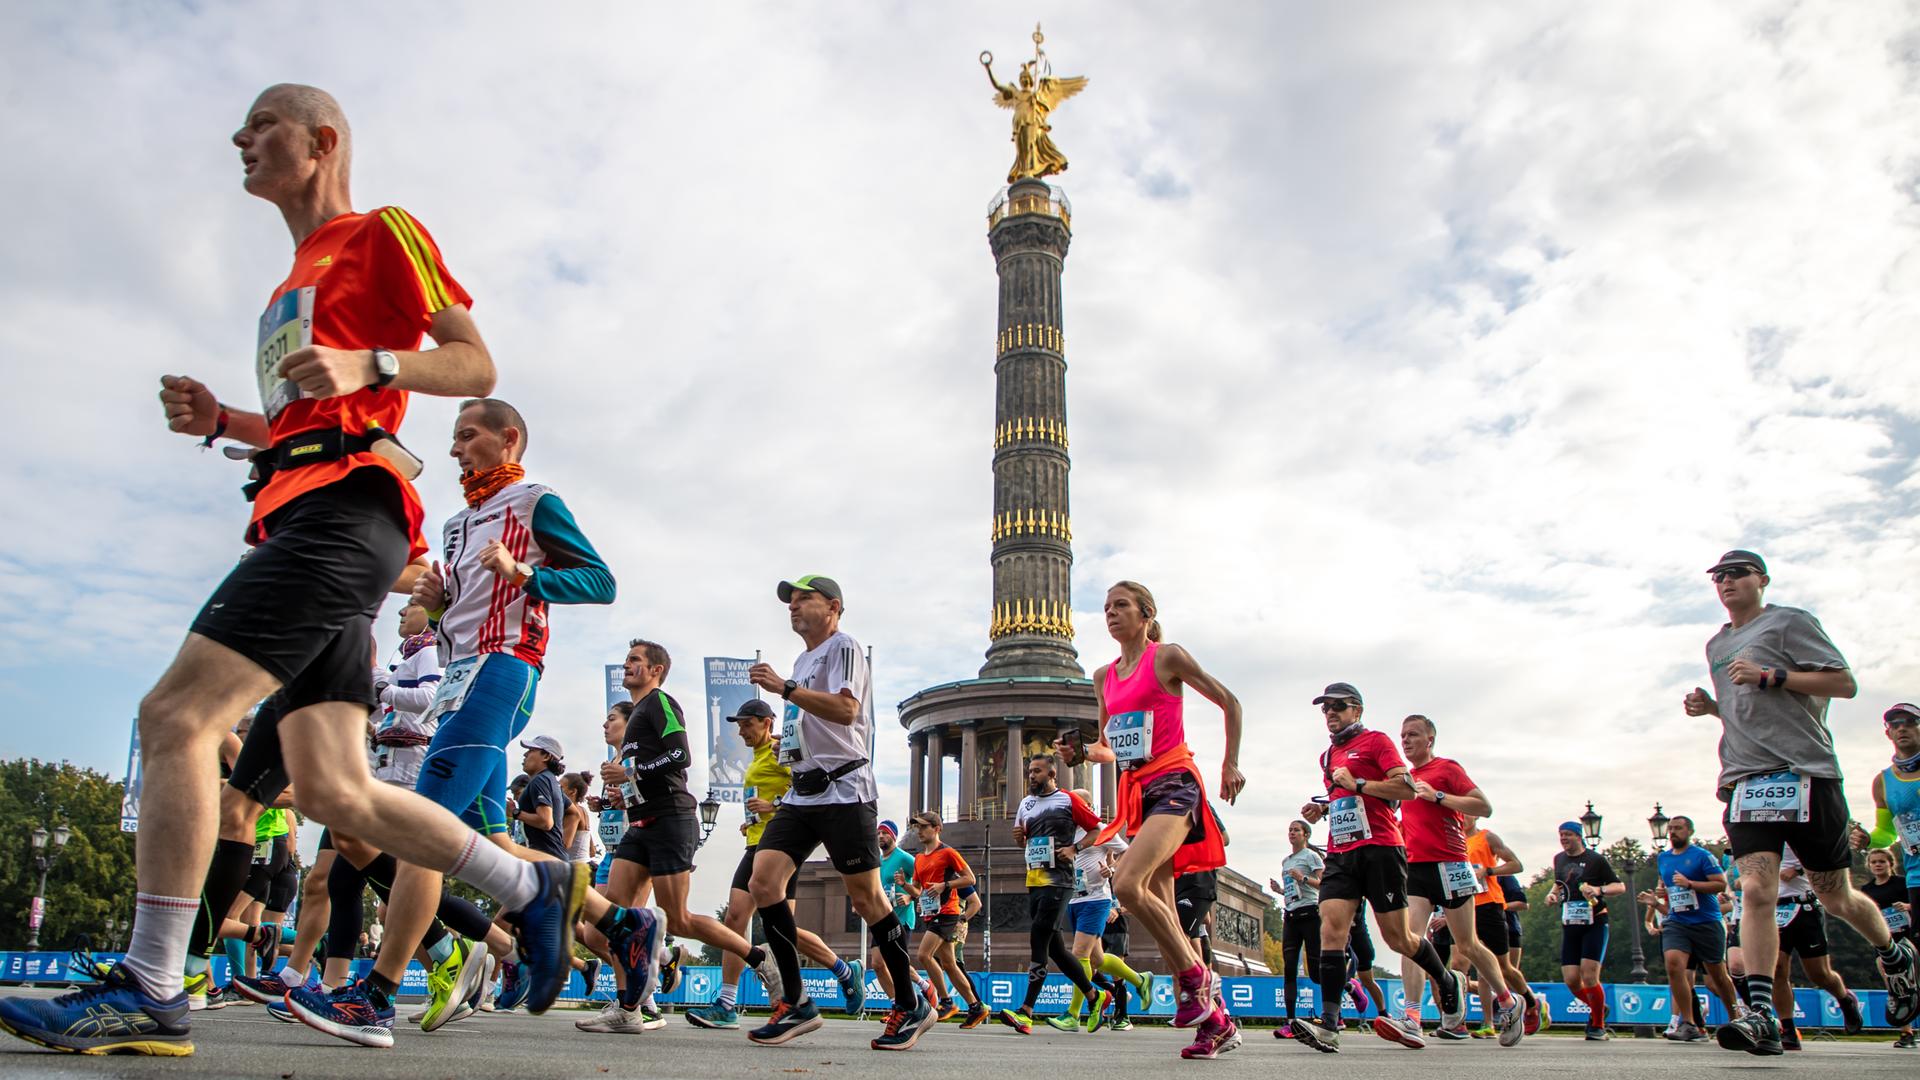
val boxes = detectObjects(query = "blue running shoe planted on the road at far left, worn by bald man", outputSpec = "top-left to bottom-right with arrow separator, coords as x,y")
0,967 -> 194,1057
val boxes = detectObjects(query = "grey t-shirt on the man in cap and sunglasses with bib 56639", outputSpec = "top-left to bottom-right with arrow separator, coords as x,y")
1707,603 -> 1847,788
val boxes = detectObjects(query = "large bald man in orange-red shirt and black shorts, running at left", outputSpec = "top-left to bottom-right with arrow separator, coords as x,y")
0,85 -> 586,1055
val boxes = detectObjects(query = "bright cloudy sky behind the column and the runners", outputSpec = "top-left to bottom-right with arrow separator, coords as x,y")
0,2 -> 1920,922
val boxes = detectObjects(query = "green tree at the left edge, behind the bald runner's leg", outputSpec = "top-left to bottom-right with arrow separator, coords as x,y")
0,757 -> 134,949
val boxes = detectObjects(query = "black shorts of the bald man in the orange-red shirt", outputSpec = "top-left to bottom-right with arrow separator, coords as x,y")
192,467 -> 407,713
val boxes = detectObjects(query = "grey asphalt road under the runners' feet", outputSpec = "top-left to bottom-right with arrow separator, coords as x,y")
0,990 -> 1920,1080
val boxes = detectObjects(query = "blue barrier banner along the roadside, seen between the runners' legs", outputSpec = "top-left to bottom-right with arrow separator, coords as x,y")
0,953 -> 1889,1028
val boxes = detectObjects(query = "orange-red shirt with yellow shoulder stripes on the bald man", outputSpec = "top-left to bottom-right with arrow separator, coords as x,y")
248,206 -> 472,557
